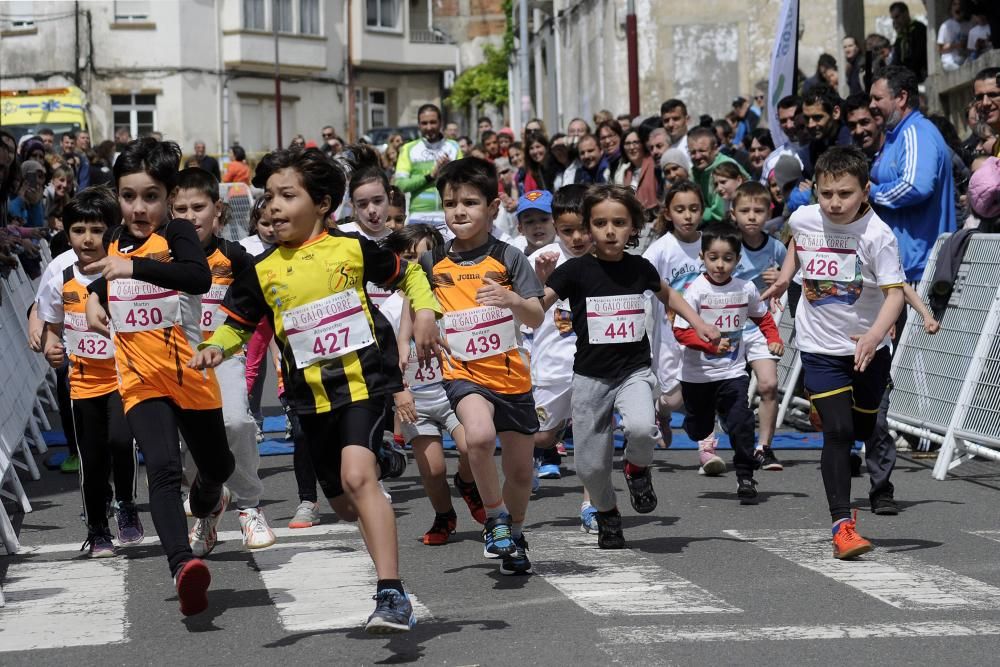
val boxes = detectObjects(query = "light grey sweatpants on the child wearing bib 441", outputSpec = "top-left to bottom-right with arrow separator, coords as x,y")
573,368 -> 656,512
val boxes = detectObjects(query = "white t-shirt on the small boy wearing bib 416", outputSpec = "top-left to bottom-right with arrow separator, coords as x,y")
675,274 -> 767,383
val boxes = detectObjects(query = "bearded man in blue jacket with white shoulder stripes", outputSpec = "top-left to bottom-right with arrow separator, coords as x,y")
869,65 -> 955,282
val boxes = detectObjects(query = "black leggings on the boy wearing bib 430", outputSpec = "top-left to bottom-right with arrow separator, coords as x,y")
125,398 -> 236,575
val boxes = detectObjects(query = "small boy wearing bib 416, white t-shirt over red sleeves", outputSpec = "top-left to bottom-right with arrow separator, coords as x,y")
674,224 -> 784,505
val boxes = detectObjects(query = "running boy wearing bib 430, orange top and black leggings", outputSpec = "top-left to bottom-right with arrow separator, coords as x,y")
83,137 -> 235,616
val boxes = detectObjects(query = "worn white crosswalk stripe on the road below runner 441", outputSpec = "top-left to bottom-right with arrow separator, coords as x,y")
529,531 -> 743,616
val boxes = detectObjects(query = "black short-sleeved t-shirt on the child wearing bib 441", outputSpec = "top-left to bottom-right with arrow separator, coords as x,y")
548,253 -> 661,380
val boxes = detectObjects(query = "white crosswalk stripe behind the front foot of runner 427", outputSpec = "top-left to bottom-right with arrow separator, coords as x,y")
252,539 -> 433,632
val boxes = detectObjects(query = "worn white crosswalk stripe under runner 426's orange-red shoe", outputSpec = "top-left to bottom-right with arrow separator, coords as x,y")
724,530 -> 1000,610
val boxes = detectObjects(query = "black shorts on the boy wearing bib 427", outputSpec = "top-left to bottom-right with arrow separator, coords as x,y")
299,397 -> 385,498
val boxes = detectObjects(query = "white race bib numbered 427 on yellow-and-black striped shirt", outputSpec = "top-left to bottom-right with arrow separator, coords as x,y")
281,290 -> 375,368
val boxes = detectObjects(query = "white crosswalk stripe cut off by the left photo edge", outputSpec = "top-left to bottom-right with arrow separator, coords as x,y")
0,558 -> 128,652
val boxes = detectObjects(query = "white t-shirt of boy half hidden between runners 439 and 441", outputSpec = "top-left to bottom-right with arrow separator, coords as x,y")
528,241 -> 576,386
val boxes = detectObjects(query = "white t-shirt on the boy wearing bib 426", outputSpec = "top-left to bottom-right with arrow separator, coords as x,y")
788,204 -> 906,356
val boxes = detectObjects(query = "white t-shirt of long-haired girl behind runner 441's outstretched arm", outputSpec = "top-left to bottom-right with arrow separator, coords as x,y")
642,233 -> 705,391
